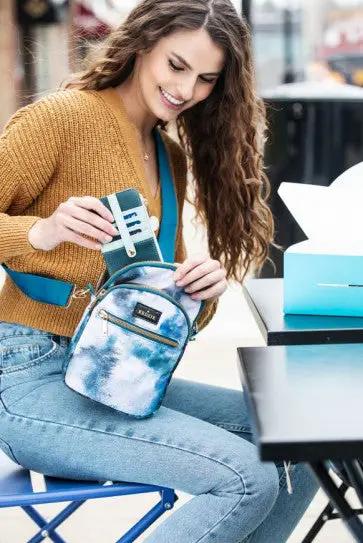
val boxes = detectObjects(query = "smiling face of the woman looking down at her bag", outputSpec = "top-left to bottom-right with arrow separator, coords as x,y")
134,28 -> 225,122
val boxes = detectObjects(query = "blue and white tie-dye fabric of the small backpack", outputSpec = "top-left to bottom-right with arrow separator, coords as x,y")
65,265 -> 201,418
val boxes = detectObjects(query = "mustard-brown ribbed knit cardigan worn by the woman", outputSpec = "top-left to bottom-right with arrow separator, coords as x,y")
0,88 -> 217,337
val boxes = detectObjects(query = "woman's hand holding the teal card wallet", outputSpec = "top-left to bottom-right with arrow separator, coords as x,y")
28,196 -> 117,251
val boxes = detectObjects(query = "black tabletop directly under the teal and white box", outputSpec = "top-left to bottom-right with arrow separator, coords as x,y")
244,279 -> 363,345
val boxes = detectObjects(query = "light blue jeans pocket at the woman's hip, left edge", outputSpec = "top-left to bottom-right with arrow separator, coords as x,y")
0,334 -> 59,374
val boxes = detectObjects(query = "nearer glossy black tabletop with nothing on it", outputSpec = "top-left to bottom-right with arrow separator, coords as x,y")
238,344 -> 363,461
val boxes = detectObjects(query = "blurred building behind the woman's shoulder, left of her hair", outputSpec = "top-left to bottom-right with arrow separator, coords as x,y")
0,0 -> 131,129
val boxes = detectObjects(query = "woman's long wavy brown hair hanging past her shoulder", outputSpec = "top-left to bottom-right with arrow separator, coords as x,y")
65,0 -> 274,281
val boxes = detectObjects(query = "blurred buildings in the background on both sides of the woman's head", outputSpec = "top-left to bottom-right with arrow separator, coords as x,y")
0,0 -> 363,129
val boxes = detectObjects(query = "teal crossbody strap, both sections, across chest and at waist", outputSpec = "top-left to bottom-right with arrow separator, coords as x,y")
2,126 -> 178,307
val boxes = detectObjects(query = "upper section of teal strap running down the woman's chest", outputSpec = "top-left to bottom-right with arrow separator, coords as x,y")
155,129 -> 178,262
